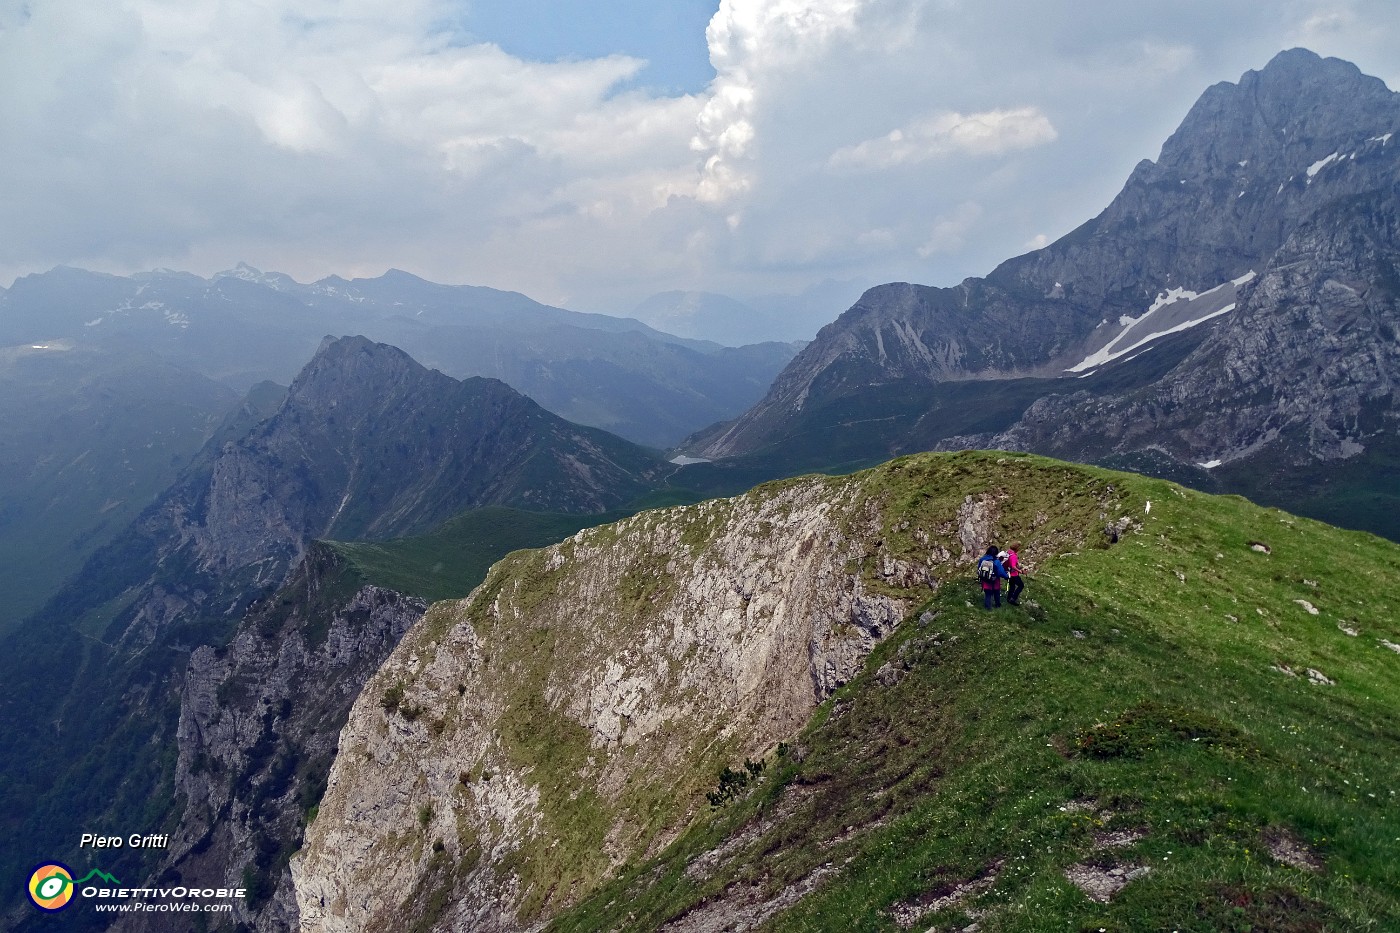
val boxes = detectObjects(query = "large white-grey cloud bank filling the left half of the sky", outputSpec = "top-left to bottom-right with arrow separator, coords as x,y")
0,0 -> 700,279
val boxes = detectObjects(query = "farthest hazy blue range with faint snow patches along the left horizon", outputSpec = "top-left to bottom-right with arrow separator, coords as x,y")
0,265 -> 797,447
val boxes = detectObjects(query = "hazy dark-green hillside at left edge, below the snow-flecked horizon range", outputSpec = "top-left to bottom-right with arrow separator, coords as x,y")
0,345 -> 235,633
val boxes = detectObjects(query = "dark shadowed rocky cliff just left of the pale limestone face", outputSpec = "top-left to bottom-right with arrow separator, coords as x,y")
120,545 -> 426,933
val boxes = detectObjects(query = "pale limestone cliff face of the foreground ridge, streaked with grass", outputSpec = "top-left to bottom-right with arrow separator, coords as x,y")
293,458 -> 1123,932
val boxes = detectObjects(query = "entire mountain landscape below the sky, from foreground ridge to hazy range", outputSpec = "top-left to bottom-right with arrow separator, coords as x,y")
0,49 -> 1400,933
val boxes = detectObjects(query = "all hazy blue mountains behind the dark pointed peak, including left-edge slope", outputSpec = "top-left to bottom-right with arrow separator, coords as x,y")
0,265 -> 798,632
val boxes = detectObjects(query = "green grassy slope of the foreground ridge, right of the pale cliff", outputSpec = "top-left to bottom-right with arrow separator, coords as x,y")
550,455 -> 1400,933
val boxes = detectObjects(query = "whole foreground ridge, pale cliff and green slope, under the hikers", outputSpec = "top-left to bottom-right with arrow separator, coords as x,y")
291,451 -> 1400,933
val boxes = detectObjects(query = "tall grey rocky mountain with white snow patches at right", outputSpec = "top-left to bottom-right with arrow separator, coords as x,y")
682,49 -> 1400,534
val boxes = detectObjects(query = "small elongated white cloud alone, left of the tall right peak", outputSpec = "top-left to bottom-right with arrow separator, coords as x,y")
827,106 -> 1056,171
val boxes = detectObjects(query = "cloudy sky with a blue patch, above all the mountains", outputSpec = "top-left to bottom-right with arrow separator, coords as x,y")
0,0 -> 1400,329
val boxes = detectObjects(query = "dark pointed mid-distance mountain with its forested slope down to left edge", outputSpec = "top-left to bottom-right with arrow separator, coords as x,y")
0,338 -> 676,913
